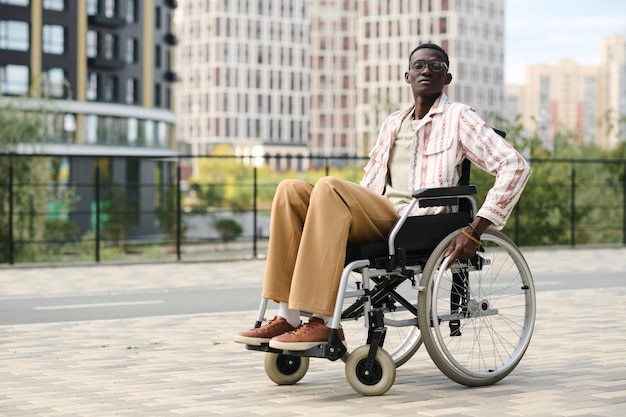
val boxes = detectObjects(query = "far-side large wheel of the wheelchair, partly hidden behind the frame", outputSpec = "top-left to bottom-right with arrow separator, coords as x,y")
341,272 -> 422,367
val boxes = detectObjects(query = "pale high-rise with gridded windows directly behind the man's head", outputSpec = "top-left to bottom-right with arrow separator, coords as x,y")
356,0 -> 504,152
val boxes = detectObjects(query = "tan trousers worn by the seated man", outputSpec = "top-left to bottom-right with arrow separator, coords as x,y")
262,177 -> 398,316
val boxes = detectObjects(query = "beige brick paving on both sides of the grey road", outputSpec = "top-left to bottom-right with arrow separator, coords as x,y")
0,248 -> 626,417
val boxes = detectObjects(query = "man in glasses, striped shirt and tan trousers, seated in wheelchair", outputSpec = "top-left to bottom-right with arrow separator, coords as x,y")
234,44 -> 530,351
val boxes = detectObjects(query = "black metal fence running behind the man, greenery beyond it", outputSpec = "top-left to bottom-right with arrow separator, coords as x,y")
0,154 -> 626,264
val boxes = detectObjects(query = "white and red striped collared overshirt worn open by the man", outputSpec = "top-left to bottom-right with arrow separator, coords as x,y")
361,94 -> 530,229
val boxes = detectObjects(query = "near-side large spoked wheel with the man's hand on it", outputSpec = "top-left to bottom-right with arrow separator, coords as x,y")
418,228 -> 535,386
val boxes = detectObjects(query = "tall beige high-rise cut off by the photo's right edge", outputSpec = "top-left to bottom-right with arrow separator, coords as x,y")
597,35 -> 626,148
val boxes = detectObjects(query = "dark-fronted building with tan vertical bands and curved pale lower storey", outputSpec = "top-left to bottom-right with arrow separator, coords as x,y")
0,0 -> 177,233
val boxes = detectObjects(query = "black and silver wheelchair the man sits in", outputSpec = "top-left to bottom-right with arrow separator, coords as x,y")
241,161 -> 536,396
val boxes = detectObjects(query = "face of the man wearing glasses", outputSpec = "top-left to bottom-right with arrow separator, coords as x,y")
404,48 -> 452,97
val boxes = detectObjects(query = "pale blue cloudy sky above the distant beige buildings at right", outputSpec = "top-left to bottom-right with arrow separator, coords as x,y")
504,0 -> 626,84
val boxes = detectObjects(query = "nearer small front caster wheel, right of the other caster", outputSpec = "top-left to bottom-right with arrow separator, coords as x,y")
346,345 -> 396,395
